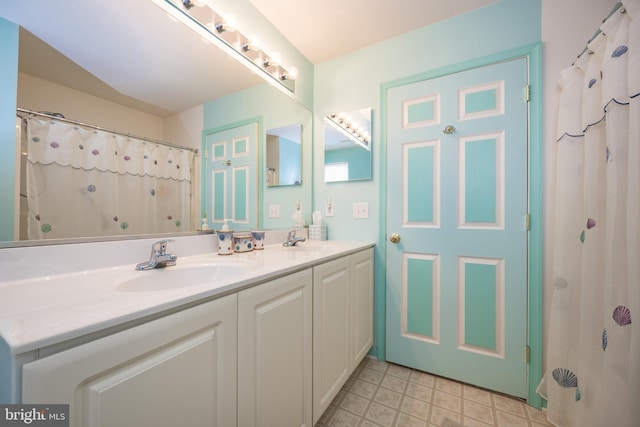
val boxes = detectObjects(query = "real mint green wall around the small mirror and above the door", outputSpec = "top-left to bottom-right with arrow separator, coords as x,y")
313,0 -> 541,394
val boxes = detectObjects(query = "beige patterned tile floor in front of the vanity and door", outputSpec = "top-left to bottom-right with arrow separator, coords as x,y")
316,357 -> 552,427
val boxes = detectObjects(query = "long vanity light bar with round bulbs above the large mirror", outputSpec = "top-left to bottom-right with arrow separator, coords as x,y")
150,0 -> 297,97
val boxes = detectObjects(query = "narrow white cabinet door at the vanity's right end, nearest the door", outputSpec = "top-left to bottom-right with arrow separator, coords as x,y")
351,248 -> 373,371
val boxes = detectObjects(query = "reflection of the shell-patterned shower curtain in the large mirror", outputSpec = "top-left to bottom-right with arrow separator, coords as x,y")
24,116 -> 194,239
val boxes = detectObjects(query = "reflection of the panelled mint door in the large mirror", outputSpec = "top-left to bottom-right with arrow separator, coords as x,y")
202,122 -> 258,230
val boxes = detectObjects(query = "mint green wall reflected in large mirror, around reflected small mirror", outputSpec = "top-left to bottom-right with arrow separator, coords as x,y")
204,83 -> 313,228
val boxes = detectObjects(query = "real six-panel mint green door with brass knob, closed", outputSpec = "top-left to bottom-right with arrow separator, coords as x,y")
386,58 -> 528,397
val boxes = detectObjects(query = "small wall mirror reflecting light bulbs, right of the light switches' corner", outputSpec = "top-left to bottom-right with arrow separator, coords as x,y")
324,108 -> 372,182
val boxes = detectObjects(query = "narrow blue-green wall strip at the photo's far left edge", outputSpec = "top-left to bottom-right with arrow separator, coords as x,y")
0,18 -> 18,241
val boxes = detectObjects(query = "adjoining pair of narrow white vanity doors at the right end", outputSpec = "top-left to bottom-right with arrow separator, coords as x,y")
313,249 -> 373,424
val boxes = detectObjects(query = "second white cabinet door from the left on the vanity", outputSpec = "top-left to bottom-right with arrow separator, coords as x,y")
238,270 -> 312,427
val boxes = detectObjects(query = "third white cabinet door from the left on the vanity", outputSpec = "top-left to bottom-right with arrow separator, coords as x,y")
313,257 -> 352,423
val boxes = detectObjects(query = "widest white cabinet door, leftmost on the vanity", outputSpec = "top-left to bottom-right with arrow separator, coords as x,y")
22,295 -> 237,427
